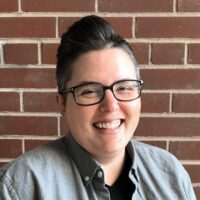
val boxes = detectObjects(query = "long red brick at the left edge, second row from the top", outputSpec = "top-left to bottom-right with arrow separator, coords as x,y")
0,17 -> 56,38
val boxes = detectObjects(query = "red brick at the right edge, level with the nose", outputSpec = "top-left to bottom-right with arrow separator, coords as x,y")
173,94 -> 200,113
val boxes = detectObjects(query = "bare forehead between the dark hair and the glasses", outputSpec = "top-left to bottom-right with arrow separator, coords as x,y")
69,48 -> 136,84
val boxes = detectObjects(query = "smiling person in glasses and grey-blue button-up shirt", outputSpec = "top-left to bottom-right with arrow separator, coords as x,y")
0,16 -> 195,200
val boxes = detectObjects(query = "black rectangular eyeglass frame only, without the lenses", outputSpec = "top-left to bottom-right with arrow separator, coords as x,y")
61,79 -> 144,106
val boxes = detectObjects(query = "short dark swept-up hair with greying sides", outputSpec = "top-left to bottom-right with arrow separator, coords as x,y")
56,15 -> 140,94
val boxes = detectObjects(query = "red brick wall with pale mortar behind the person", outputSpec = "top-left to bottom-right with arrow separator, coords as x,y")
0,0 -> 200,198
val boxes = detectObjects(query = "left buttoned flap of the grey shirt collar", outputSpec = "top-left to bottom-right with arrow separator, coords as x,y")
65,133 -> 100,185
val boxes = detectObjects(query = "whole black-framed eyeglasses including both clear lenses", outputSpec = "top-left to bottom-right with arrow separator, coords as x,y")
63,79 -> 144,106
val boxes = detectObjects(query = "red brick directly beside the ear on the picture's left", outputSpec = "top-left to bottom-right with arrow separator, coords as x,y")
23,92 -> 58,112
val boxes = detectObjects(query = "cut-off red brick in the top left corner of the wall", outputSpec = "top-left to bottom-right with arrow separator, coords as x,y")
0,0 -> 18,12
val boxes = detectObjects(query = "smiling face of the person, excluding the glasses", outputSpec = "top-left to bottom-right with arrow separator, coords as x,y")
64,48 -> 141,160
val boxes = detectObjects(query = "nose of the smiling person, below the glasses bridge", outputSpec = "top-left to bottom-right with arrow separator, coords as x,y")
100,90 -> 119,112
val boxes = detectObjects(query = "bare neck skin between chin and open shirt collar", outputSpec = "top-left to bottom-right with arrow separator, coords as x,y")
98,149 -> 125,185
